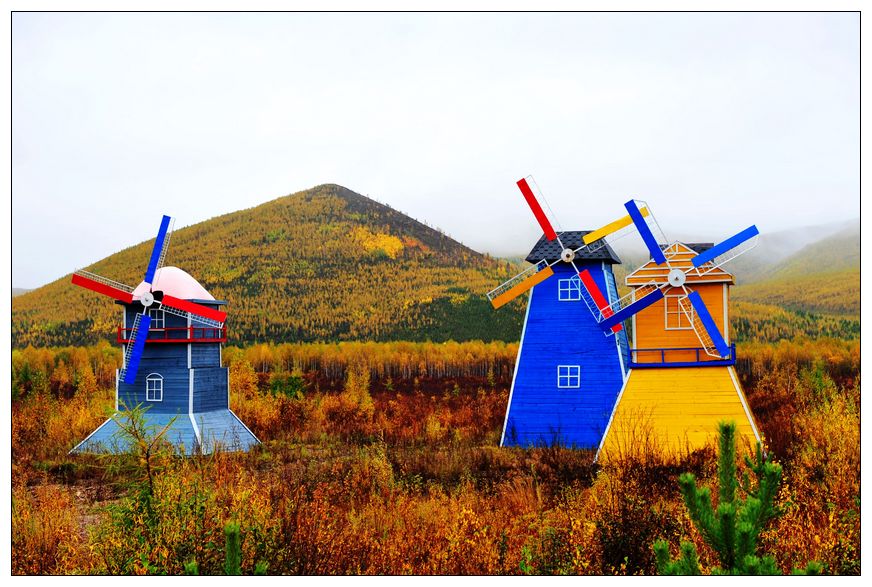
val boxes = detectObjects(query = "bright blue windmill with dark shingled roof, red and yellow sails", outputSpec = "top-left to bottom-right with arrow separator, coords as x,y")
487,176 -> 668,448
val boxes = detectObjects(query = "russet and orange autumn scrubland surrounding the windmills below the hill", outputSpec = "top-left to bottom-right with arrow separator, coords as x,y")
12,339 -> 860,575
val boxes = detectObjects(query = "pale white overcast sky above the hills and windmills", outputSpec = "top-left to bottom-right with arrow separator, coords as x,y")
12,13 -> 860,287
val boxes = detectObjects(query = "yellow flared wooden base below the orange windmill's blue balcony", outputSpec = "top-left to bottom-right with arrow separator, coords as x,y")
600,367 -> 757,462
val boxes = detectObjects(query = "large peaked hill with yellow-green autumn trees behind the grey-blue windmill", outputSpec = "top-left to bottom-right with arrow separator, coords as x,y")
12,184 -> 525,347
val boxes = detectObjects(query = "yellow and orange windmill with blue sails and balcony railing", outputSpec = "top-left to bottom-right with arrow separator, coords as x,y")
583,200 -> 760,458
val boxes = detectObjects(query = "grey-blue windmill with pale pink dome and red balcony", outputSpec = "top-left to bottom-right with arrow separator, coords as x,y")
71,216 -> 259,454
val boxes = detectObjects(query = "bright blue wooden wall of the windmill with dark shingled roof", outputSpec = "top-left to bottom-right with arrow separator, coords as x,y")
501,261 -> 628,448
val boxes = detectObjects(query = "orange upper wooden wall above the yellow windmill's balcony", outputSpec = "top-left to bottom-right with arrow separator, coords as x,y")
635,283 -> 726,363
